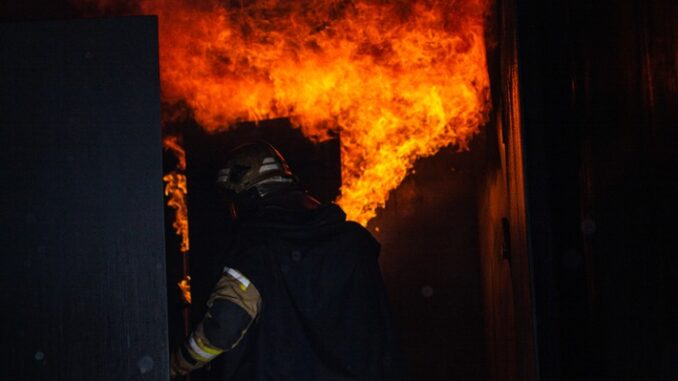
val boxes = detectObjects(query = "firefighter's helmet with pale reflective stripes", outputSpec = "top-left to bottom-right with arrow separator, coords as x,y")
217,141 -> 296,195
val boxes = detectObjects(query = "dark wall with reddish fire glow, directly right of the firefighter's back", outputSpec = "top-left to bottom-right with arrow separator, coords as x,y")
368,145 -> 489,381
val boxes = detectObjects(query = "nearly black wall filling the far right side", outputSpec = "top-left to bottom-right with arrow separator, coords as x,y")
517,0 -> 678,380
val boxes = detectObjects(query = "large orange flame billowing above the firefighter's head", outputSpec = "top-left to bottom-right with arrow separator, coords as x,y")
147,0 -> 489,224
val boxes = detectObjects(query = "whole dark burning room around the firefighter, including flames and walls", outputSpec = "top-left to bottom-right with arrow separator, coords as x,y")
0,0 -> 678,381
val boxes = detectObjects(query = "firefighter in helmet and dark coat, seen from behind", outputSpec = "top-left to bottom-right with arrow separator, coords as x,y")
171,142 -> 403,381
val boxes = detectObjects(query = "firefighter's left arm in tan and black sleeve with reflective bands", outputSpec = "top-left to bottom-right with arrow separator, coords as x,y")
170,267 -> 261,377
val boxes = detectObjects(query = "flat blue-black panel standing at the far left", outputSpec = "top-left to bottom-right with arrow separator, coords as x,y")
0,17 -> 168,381
